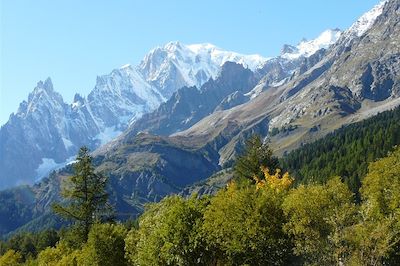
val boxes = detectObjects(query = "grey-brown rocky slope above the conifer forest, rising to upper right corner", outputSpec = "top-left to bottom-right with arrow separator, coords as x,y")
176,0 -> 400,158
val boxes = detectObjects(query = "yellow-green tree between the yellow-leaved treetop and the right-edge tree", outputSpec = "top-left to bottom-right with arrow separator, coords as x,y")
283,178 -> 357,265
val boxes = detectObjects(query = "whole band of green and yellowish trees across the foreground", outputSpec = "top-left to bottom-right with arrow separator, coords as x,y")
0,136 -> 400,266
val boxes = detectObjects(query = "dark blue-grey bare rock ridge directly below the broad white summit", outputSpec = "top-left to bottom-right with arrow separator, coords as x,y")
129,62 -> 257,136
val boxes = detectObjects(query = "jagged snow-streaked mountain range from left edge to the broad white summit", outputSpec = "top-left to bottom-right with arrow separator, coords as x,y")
0,42 -> 266,189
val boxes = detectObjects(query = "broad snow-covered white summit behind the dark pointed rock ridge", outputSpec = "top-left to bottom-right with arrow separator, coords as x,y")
138,42 -> 267,99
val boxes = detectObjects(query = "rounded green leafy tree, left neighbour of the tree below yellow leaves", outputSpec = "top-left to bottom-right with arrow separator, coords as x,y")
130,196 -> 210,265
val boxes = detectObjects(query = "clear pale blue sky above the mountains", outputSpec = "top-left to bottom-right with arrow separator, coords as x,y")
0,0 -> 379,124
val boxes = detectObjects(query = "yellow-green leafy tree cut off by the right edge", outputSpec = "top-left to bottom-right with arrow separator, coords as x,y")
349,148 -> 400,265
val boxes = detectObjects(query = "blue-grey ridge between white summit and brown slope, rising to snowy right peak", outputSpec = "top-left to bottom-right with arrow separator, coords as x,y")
122,30 -> 341,139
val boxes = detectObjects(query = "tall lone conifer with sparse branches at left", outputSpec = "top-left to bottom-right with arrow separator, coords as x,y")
53,147 -> 111,241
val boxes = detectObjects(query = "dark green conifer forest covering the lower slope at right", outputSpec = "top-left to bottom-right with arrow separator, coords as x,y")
282,108 -> 400,195
